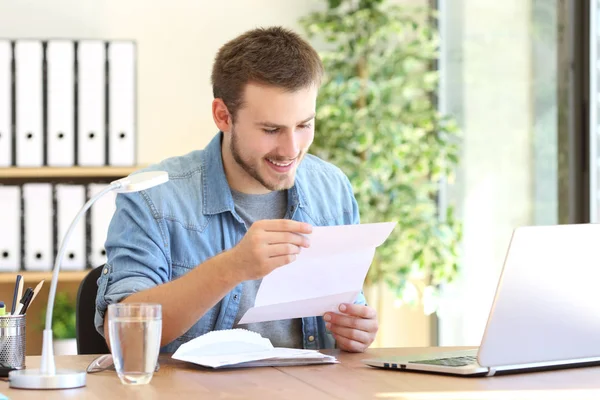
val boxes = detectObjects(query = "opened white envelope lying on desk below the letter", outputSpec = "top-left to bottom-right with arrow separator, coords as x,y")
172,329 -> 338,368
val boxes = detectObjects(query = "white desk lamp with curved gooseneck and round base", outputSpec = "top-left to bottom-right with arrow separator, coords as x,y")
8,171 -> 169,389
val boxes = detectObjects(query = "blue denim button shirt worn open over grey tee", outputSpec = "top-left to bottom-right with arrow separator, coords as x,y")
95,132 -> 365,353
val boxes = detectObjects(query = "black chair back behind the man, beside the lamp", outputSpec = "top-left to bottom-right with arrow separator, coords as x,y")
76,265 -> 110,354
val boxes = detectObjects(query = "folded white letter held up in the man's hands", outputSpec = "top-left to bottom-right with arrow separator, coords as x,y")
239,222 -> 396,324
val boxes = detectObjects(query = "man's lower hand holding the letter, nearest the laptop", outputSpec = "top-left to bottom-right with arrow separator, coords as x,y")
323,304 -> 379,353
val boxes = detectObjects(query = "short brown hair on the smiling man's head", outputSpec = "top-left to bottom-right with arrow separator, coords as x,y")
211,27 -> 323,118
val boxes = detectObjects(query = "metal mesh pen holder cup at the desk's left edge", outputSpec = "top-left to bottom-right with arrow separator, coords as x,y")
0,314 -> 25,369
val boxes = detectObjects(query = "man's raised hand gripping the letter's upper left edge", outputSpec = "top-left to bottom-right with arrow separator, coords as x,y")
230,219 -> 312,280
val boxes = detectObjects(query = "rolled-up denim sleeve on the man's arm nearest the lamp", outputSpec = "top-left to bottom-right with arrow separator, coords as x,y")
94,191 -> 171,337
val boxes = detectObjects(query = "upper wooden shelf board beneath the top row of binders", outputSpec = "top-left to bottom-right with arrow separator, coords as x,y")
0,166 -> 143,180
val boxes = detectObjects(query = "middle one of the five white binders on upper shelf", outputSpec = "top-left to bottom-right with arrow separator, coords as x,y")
46,40 -> 75,167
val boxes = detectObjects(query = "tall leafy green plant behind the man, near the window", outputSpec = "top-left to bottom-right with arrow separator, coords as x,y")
300,0 -> 461,311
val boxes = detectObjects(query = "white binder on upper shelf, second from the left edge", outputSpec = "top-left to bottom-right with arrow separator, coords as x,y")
15,40 -> 44,167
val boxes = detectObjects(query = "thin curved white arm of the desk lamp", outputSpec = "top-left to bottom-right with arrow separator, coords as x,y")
40,181 -> 123,374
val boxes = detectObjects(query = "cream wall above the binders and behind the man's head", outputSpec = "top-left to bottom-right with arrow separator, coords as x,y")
0,0 -> 324,164
